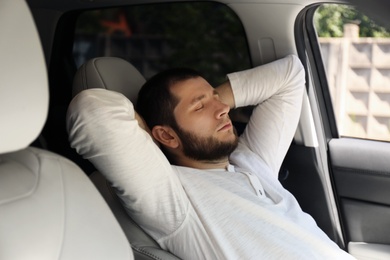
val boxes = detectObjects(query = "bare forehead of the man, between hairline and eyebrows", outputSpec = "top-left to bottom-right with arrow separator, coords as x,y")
171,77 -> 214,103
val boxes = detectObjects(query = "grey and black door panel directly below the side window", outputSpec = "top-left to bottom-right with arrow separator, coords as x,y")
329,138 -> 390,245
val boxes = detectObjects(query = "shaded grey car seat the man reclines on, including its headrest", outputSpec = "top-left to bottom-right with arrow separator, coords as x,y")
73,57 -> 178,260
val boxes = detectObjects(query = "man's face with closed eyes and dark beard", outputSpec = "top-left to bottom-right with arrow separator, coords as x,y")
171,77 -> 238,161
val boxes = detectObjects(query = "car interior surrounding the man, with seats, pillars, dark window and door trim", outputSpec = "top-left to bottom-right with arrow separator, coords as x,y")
0,0 -> 390,259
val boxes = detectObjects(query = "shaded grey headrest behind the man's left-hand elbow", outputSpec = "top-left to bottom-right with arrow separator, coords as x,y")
72,57 -> 145,104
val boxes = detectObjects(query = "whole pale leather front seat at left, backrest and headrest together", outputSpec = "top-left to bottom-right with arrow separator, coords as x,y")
0,0 -> 133,260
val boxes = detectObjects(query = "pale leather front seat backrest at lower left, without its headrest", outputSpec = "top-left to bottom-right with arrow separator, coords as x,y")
0,148 -> 133,260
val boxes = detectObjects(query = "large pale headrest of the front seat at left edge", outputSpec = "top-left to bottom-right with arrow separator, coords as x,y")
0,0 -> 49,153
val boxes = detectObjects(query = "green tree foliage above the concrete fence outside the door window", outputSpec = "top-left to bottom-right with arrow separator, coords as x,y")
314,4 -> 390,37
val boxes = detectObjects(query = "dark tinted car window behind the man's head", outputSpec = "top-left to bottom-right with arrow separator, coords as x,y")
73,2 -> 251,84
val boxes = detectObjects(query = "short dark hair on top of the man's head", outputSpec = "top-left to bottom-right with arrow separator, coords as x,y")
136,68 -> 201,129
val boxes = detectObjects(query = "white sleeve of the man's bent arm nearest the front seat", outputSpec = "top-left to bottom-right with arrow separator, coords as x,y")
67,89 -> 188,239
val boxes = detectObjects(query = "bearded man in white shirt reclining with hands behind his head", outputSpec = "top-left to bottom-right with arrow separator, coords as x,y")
68,55 -> 351,259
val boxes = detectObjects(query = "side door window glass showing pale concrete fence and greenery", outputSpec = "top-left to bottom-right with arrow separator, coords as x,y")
314,4 -> 390,141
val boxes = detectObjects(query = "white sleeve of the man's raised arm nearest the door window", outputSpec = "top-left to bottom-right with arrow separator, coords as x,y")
228,55 -> 305,177
